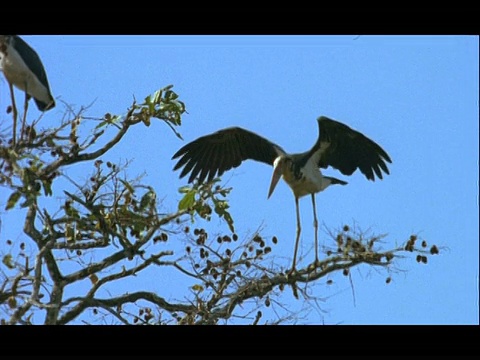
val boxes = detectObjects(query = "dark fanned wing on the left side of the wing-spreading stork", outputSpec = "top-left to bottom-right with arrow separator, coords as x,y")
172,127 -> 285,183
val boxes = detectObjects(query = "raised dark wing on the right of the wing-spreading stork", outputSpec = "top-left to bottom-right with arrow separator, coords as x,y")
311,116 -> 392,181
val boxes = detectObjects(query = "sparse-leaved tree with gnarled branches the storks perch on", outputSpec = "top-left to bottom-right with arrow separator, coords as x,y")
0,86 -> 438,324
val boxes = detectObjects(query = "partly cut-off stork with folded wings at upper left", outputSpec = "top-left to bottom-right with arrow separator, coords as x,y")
0,35 -> 55,145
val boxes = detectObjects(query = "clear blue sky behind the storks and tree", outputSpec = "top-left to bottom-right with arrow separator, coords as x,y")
0,35 -> 479,324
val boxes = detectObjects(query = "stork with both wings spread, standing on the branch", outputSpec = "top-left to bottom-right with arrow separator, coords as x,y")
172,116 -> 392,272
